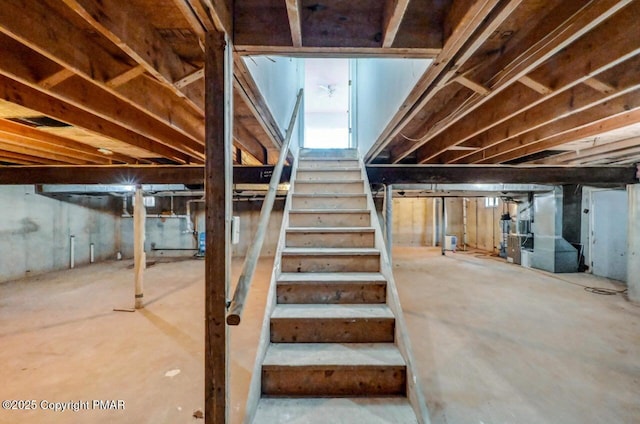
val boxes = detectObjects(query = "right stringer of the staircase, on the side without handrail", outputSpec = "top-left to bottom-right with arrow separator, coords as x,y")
358,158 -> 431,424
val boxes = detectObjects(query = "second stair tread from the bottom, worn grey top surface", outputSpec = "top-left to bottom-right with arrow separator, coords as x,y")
262,343 -> 405,368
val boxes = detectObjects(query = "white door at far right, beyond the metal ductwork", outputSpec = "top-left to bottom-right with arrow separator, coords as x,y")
590,190 -> 629,281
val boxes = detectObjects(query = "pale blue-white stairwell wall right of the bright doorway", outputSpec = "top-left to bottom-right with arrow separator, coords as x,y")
354,58 -> 431,156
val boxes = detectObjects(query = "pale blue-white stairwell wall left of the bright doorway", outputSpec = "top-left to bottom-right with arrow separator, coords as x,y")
244,56 -> 304,154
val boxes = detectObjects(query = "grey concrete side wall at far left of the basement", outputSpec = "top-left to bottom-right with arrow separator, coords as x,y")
0,185 -> 120,282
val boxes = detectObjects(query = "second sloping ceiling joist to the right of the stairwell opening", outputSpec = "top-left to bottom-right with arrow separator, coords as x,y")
393,0 -> 631,163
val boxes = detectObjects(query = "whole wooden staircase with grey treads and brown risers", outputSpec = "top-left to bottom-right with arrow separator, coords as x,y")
245,149 -> 429,424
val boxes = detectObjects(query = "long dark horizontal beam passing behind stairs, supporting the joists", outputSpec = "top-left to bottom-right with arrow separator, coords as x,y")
0,163 -> 640,185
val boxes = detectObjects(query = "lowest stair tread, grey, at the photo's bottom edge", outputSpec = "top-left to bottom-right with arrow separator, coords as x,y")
253,396 -> 418,424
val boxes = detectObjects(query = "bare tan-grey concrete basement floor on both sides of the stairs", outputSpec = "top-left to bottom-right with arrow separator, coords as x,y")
0,248 -> 640,424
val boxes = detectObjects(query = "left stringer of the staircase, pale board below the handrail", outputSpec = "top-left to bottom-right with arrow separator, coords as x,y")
242,157 -> 298,424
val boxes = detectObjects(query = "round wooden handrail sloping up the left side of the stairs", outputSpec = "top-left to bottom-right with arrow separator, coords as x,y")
227,89 -> 303,325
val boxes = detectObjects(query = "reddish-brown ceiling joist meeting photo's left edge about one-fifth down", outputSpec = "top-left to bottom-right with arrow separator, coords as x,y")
0,75 -> 191,163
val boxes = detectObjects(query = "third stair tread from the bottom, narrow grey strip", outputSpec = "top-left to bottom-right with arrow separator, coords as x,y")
271,304 -> 394,319
